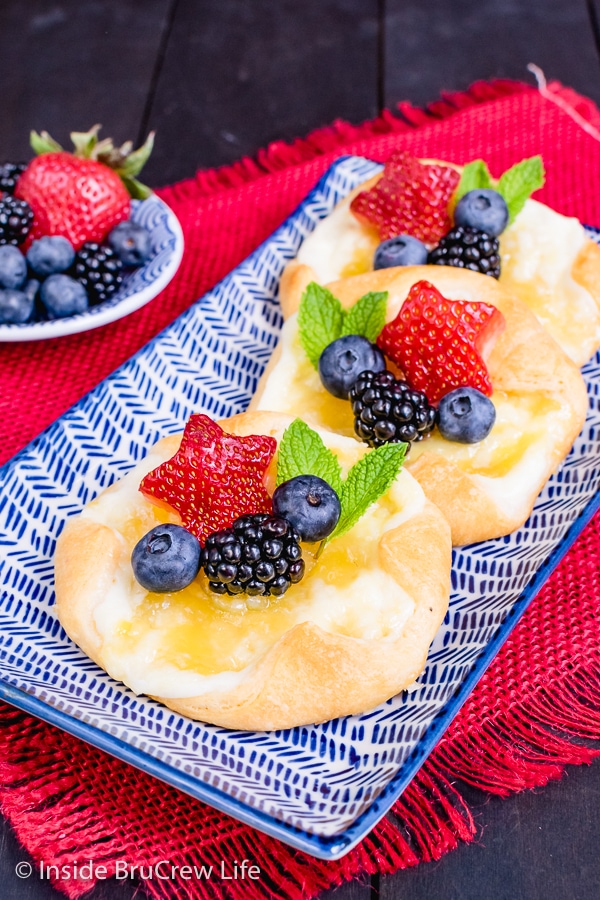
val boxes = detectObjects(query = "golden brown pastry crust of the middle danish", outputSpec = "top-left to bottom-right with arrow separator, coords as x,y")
252,263 -> 588,545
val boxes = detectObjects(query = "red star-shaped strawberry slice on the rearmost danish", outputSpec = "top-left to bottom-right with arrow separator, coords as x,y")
350,152 -> 460,244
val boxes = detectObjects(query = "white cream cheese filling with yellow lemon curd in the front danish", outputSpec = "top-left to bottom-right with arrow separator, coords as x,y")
83,433 -> 425,699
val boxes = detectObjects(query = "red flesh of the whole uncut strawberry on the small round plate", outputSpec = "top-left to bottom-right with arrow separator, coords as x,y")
15,151 -> 131,250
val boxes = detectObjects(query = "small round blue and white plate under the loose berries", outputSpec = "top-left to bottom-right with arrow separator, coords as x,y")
0,194 -> 183,342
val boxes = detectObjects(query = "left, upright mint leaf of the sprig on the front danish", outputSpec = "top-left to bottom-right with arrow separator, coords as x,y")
277,419 -> 342,497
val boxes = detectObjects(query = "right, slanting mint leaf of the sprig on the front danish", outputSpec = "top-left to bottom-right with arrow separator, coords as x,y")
327,444 -> 406,541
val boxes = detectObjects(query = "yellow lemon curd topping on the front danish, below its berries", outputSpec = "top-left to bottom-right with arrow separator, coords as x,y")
106,487 -> 415,675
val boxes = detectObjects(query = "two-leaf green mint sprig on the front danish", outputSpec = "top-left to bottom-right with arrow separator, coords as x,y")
277,419 -> 406,542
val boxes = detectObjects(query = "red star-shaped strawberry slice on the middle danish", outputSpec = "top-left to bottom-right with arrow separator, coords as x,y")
377,281 -> 506,403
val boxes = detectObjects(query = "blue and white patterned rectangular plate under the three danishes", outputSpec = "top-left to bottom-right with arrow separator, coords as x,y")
0,157 -> 600,859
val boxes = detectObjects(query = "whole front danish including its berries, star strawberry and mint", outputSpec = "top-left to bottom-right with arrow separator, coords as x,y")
56,412 -> 450,730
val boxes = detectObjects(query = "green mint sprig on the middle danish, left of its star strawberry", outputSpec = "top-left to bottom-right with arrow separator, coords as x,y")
298,281 -> 388,369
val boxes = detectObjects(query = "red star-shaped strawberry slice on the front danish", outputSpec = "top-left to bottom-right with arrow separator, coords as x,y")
140,415 -> 277,543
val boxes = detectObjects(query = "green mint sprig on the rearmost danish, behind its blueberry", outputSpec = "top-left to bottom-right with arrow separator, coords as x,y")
452,156 -> 545,222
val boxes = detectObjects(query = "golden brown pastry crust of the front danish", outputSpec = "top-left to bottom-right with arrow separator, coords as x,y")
56,412 -> 451,730
